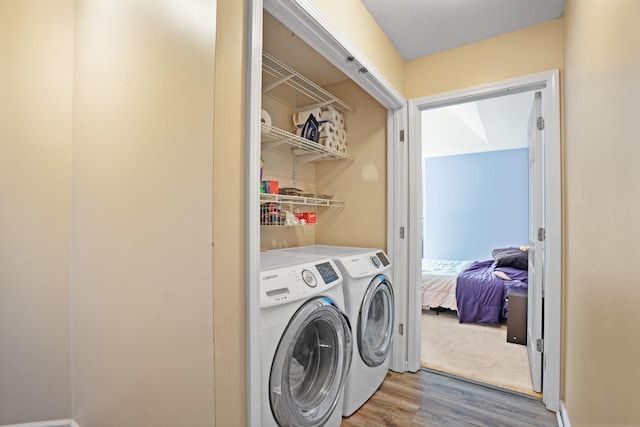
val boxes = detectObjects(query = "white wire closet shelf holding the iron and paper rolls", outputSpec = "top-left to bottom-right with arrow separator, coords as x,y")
261,123 -> 352,164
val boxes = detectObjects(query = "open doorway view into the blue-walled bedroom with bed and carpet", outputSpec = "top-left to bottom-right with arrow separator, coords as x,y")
420,91 -> 540,396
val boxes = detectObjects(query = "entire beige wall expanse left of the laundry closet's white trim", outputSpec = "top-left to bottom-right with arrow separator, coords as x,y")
0,0 -> 246,426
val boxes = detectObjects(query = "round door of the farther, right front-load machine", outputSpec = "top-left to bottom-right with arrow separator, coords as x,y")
358,274 -> 394,367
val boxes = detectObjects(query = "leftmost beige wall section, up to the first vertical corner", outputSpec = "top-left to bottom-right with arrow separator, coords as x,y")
0,0 -> 73,425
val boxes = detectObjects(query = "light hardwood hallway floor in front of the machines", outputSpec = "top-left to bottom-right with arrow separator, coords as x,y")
342,370 -> 558,427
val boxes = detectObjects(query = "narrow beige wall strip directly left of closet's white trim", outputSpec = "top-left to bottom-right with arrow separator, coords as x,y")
213,0 -> 247,427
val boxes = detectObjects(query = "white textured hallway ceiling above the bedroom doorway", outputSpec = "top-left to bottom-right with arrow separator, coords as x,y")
362,0 -> 565,61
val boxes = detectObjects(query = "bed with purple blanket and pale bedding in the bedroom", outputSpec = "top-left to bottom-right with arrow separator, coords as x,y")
422,248 -> 528,323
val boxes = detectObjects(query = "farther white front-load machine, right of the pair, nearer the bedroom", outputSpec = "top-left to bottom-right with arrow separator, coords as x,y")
272,245 -> 395,417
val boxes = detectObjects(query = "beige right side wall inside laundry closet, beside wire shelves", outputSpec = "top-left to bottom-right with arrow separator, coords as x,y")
316,81 -> 387,249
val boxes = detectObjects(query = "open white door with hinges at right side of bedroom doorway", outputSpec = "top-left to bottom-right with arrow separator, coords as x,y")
527,92 -> 544,393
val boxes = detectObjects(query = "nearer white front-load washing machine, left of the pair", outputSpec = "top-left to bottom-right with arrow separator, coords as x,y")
259,252 -> 353,427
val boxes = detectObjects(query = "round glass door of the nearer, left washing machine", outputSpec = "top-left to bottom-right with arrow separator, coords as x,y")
269,297 -> 353,427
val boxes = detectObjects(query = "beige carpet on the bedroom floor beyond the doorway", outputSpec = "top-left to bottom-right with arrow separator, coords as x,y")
421,311 -> 539,396
